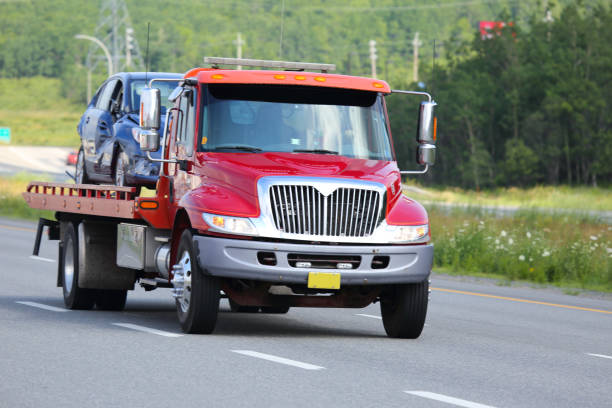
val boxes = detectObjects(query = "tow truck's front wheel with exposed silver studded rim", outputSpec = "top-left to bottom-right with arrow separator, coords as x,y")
172,230 -> 221,334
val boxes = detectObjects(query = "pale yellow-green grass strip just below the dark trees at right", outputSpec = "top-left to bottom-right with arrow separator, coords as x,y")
407,184 -> 612,211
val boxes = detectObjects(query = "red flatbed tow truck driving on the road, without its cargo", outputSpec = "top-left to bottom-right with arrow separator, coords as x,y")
23,58 -> 436,338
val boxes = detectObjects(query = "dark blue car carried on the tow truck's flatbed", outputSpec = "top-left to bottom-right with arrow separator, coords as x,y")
75,72 -> 183,187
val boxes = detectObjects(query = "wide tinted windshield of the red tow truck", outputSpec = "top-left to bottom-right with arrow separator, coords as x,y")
199,84 -> 392,160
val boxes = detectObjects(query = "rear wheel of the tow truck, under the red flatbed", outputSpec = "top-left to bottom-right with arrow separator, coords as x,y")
62,222 -> 96,310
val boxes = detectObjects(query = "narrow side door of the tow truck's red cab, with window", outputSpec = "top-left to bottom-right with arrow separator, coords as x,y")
168,87 -> 197,206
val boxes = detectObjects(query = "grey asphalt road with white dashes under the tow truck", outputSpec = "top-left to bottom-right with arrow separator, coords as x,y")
0,219 -> 612,407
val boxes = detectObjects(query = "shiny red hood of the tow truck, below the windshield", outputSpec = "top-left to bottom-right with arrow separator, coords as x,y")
186,152 -> 401,217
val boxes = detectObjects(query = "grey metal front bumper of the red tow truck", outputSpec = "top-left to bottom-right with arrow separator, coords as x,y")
193,235 -> 433,286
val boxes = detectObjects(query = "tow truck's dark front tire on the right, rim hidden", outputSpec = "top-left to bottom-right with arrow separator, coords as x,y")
380,280 -> 429,339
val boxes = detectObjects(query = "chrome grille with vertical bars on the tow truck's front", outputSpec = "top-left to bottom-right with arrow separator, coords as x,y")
269,185 -> 381,237
